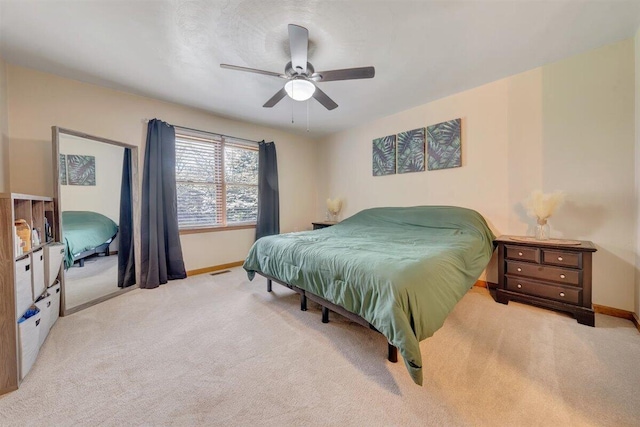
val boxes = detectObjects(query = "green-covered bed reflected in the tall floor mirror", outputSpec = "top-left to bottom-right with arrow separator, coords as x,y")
62,211 -> 118,269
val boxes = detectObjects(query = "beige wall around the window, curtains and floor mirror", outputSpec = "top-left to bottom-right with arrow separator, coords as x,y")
7,65 -> 316,270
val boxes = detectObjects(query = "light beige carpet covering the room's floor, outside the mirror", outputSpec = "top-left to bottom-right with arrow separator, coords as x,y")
0,268 -> 640,426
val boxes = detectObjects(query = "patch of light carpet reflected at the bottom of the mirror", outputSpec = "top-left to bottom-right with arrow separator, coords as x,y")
64,255 -> 121,309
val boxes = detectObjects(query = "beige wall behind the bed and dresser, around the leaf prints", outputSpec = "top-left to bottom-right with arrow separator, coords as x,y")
316,40 -> 636,310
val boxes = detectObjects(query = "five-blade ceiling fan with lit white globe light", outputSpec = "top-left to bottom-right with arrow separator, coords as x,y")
220,24 -> 376,110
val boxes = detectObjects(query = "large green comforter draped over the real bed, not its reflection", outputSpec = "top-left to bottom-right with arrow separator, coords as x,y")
244,206 -> 495,385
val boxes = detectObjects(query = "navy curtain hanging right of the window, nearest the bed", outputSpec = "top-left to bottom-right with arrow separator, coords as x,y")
256,141 -> 280,240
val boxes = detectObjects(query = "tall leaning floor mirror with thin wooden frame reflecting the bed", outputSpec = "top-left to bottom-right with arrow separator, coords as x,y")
53,127 -> 138,315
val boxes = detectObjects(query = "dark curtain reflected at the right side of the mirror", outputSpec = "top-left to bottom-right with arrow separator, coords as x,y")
118,148 -> 136,288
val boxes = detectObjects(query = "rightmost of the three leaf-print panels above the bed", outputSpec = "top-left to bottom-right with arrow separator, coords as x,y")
427,119 -> 462,170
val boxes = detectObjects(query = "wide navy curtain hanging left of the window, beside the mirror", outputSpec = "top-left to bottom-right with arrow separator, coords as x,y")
140,119 -> 187,289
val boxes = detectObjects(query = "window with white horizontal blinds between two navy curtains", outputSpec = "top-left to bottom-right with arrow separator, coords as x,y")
176,130 -> 258,230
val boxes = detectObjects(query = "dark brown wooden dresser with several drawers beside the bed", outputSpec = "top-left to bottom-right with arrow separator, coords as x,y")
495,236 -> 596,326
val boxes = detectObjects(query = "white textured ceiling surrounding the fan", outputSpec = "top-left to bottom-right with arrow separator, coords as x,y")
0,0 -> 640,137
